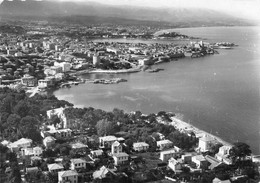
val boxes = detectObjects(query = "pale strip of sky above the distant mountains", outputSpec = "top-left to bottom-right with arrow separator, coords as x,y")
0,0 -> 260,24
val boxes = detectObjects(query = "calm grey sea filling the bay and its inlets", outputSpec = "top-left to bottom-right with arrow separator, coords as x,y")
54,26 -> 260,154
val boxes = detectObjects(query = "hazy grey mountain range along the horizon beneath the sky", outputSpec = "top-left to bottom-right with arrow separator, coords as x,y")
0,0 -> 252,26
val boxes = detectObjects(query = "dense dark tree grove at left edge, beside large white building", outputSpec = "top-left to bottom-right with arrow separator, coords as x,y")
0,88 -> 72,142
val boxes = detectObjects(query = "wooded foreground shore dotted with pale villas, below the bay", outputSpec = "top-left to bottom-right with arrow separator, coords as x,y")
0,88 -> 260,183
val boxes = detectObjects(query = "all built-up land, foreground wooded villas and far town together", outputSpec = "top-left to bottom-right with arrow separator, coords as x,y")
0,22 -> 260,183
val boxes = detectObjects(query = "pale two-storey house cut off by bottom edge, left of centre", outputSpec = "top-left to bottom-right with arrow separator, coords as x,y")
58,170 -> 79,183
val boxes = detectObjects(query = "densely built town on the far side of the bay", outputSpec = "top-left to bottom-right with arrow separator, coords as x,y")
0,22 -> 225,96
